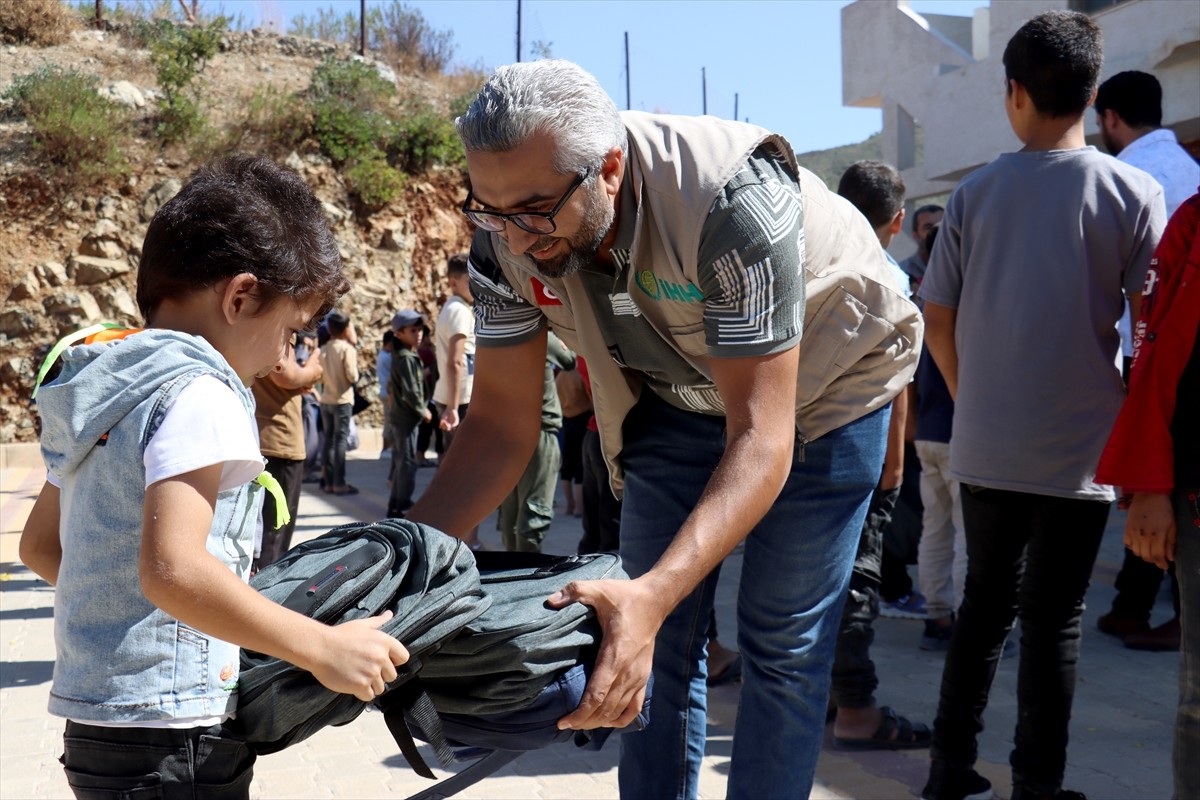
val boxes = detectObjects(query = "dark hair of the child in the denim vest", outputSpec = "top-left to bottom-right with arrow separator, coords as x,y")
137,155 -> 350,321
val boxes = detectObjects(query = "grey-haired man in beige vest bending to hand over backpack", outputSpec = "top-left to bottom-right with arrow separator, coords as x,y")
409,60 -> 922,799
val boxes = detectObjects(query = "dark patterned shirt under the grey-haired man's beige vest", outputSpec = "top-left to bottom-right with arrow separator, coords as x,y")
470,148 -> 804,415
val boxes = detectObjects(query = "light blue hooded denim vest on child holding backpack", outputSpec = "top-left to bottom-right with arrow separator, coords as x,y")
37,330 -> 263,722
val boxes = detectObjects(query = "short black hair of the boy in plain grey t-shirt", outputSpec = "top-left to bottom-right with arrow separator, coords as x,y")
1003,11 -> 1104,118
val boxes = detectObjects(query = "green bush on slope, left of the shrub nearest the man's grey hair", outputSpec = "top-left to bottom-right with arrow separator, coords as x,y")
308,59 -> 396,164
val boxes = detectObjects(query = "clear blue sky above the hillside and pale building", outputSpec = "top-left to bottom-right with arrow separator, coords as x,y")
211,0 -> 988,152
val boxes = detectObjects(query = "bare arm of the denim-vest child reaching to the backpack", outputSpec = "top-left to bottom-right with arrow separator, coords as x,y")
139,464 -> 408,700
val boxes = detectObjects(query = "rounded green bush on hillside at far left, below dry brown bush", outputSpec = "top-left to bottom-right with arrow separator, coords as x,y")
4,66 -> 130,184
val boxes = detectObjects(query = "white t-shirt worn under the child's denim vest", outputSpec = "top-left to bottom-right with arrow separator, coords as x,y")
47,375 -> 263,728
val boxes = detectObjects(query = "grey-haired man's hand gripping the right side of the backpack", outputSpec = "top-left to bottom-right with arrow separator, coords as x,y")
548,581 -> 671,730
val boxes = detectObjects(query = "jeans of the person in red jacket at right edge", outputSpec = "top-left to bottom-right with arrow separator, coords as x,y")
1174,488 -> 1200,800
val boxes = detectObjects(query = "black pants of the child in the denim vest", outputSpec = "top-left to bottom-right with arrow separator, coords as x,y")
59,721 -> 254,800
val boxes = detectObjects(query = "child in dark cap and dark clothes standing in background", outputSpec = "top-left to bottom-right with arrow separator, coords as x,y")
388,309 -> 432,517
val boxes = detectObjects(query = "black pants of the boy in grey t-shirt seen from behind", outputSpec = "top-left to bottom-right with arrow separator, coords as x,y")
931,483 -> 1110,795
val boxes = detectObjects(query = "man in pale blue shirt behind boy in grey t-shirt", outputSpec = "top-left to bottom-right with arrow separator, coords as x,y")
1094,71 -> 1200,651
